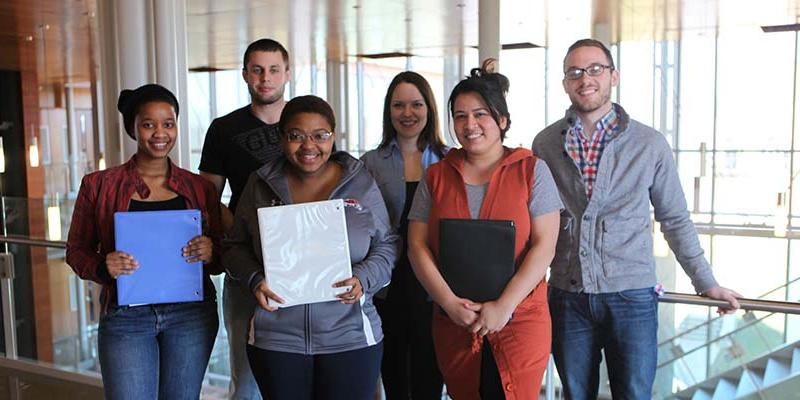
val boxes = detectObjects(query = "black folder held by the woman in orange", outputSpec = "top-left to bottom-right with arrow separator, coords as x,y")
439,219 -> 516,302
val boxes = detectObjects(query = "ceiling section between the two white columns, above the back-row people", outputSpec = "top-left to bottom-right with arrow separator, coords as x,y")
187,0 -> 477,68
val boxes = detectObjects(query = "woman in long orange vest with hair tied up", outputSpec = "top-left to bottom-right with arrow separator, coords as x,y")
408,60 -> 562,400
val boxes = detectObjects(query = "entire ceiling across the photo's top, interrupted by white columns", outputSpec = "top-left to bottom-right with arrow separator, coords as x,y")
0,0 -> 800,84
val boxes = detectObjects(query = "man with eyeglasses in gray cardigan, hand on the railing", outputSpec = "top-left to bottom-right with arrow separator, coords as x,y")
533,39 -> 741,399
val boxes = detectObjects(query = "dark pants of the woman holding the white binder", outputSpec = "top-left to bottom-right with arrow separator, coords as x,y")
247,342 -> 383,400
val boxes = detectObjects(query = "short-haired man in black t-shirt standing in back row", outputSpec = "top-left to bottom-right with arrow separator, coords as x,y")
200,39 -> 290,399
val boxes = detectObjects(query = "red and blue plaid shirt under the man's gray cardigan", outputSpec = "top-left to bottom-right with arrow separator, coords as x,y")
564,107 -> 619,199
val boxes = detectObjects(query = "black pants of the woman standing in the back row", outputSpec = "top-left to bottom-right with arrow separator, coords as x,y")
373,298 -> 443,400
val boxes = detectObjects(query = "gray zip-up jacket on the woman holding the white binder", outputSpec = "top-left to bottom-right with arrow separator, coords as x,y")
224,151 -> 399,354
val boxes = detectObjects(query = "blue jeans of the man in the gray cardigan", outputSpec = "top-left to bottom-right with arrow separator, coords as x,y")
548,287 -> 658,400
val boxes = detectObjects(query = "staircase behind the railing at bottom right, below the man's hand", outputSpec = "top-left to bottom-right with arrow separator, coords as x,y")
652,277 -> 800,400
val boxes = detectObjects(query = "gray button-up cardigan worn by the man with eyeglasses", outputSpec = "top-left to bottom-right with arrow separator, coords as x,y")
533,104 -> 717,293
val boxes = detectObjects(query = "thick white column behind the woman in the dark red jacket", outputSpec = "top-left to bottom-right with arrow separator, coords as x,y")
97,0 -> 191,168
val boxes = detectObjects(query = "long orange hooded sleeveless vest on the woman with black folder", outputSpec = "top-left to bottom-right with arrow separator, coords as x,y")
427,148 -> 551,400
